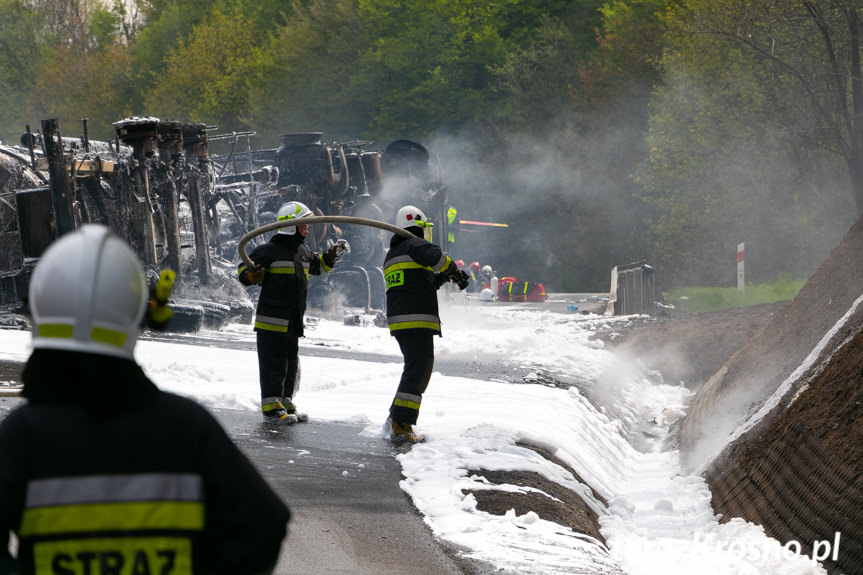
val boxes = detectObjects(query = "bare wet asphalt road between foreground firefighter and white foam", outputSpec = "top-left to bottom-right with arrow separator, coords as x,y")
0,362 -> 486,575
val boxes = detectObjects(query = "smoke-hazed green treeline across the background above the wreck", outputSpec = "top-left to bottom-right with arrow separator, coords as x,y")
0,0 -> 863,291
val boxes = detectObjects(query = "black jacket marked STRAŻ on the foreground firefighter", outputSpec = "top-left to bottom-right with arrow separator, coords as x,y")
0,349 -> 290,575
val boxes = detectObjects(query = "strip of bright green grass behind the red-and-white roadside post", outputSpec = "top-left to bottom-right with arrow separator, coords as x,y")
664,279 -> 806,313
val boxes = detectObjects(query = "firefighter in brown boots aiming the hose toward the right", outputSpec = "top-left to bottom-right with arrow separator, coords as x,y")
384,206 -> 467,443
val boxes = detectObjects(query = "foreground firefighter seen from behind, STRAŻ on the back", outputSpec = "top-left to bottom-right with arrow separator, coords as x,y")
0,224 -> 290,575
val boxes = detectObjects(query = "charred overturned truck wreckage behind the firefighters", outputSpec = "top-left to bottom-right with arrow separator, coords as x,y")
0,117 -> 456,331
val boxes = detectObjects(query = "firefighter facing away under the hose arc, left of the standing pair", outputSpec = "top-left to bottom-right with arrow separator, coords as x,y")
237,202 -> 344,423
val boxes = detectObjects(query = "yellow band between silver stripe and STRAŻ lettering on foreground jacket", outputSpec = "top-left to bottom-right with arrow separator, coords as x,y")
20,501 -> 204,537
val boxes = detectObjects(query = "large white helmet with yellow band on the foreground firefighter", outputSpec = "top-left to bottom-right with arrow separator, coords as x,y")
30,224 -> 147,359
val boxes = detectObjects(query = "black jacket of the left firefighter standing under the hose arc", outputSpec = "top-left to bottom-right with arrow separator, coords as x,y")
237,233 -> 335,336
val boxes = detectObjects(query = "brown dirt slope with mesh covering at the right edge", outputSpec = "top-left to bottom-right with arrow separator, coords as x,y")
680,214 -> 863,574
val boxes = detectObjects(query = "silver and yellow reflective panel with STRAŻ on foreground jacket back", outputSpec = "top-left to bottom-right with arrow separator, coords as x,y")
19,473 -> 204,575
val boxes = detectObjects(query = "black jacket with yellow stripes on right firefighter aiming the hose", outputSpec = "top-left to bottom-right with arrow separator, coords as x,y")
384,235 -> 455,335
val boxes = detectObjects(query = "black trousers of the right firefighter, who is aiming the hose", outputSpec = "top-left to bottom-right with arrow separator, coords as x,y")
390,331 -> 434,425
